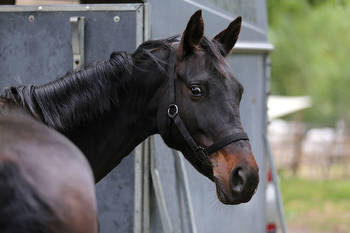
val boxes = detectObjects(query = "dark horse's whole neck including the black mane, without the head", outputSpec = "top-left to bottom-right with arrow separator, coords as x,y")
1,49 -> 170,181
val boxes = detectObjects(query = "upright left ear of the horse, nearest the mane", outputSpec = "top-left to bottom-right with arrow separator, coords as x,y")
178,10 -> 204,57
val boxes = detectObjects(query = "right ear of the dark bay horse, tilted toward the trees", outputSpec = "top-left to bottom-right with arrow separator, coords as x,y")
212,16 -> 242,57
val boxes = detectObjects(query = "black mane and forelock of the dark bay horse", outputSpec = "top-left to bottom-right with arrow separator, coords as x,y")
0,35 -> 225,132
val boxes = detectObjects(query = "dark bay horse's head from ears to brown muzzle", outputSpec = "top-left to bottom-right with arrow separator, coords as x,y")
158,11 -> 259,204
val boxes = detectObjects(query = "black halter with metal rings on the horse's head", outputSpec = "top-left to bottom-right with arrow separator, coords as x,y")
168,50 -> 249,161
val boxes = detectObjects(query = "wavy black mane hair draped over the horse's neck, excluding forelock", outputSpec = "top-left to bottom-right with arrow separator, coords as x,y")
1,52 -> 133,131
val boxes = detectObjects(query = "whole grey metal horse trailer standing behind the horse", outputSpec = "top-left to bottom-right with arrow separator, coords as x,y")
0,0 -> 272,233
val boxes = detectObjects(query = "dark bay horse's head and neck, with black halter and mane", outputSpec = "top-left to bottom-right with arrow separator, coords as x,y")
0,11 -> 259,231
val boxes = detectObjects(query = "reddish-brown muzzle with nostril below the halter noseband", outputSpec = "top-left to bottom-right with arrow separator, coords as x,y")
210,141 -> 259,205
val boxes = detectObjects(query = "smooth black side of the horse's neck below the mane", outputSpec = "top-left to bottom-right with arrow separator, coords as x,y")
66,68 -> 167,181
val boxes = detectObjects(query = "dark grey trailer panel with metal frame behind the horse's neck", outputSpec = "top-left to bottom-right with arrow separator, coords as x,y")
0,4 -> 144,232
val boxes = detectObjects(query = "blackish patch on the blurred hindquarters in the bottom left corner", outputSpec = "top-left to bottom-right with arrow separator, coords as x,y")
0,161 -> 60,233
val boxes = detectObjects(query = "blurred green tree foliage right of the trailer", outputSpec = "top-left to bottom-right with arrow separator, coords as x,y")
268,0 -> 350,125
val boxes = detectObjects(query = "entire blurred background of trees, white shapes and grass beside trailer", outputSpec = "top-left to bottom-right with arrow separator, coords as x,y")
267,0 -> 350,233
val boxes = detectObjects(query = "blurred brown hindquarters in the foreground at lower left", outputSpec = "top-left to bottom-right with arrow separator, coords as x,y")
0,104 -> 97,233
